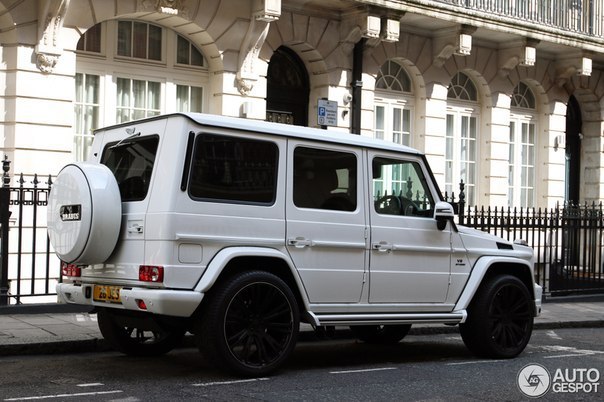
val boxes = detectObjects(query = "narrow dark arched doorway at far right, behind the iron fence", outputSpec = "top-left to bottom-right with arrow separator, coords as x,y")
564,96 -> 582,204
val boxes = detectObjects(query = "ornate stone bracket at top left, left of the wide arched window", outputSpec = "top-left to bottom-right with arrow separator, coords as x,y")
35,0 -> 69,73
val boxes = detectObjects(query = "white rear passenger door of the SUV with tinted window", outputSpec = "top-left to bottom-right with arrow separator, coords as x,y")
286,140 -> 368,303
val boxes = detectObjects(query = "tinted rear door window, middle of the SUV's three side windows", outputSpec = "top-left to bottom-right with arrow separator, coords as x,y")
293,147 -> 357,211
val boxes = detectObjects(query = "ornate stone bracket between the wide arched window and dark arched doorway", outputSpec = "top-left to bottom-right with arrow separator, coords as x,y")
235,0 -> 281,96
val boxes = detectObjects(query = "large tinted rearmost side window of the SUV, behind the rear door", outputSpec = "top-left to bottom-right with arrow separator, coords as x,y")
189,134 -> 279,205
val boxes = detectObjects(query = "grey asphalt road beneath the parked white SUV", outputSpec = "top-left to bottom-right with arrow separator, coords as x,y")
0,328 -> 604,401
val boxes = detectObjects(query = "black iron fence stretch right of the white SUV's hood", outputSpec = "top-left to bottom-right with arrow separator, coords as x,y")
460,203 -> 604,296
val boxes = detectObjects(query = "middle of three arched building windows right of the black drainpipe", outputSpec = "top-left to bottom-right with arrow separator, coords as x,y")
445,72 -> 480,205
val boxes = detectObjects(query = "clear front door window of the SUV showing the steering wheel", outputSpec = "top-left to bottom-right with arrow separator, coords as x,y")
372,158 -> 434,217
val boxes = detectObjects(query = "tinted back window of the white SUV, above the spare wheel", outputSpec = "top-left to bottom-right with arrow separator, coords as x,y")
101,136 -> 159,202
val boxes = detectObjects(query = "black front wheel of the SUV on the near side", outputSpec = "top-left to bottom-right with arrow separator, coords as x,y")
459,275 -> 534,359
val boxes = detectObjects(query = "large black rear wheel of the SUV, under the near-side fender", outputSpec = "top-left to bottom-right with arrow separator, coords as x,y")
196,271 -> 300,377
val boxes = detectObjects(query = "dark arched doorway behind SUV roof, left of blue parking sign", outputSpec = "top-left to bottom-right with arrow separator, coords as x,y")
266,46 -> 310,126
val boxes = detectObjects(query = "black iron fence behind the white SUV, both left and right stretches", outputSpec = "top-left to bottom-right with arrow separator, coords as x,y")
0,157 -> 604,306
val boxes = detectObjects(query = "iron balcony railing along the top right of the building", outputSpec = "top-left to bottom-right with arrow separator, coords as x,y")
434,0 -> 604,37
